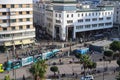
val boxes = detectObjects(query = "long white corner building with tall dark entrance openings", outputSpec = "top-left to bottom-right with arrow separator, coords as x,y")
33,0 -> 114,40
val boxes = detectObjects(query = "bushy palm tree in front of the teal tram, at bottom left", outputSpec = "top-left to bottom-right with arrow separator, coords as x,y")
29,60 -> 47,80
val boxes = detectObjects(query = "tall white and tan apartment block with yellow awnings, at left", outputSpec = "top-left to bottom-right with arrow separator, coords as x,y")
0,0 -> 35,46
